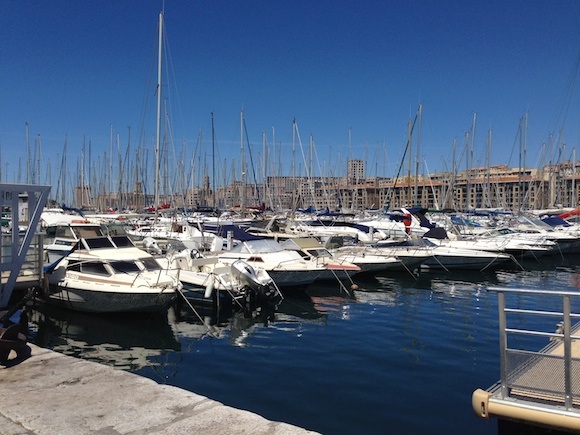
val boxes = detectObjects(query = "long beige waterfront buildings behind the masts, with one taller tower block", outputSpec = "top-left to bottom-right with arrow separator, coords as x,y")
76,160 -> 580,211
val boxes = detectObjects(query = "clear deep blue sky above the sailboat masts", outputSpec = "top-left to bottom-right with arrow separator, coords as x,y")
0,0 -> 580,192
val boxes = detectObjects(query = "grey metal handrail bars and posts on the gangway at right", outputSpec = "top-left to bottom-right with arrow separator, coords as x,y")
487,287 -> 580,410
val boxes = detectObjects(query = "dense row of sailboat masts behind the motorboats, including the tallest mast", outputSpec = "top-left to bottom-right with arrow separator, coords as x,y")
0,12 -> 575,215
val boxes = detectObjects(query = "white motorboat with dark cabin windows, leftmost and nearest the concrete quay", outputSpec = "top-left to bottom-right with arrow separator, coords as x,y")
42,236 -> 181,313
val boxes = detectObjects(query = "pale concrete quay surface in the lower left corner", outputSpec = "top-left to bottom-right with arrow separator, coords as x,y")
0,343 -> 315,435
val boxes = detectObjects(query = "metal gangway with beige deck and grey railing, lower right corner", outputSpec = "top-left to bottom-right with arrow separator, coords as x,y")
472,288 -> 580,431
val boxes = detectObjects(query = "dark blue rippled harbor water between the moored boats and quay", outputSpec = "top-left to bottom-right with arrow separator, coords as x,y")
27,254 -> 580,434
